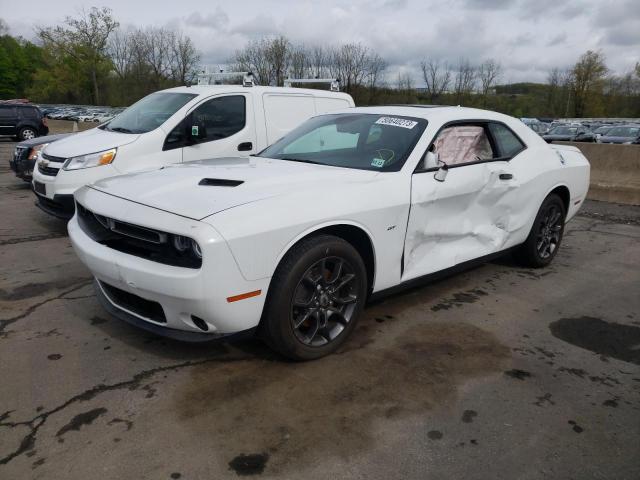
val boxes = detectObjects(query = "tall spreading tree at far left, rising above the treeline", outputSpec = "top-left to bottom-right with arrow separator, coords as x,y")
36,7 -> 118,104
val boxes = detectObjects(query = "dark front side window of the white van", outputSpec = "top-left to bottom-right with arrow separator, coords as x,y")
187,95 -> 247,143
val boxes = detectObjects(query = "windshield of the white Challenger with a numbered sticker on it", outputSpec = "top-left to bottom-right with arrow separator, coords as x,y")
259,113 -> 427,171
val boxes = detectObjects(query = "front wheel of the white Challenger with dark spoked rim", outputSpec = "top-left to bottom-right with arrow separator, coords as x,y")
260,235 -> 367,360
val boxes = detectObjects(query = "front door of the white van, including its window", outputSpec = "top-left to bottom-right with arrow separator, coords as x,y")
182,93 -> 257,162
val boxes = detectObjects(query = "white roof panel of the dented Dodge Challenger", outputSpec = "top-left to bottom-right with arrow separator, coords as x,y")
324,105 -> 524,125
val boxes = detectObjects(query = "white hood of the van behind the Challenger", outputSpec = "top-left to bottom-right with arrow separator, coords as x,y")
45,128 -> 140,158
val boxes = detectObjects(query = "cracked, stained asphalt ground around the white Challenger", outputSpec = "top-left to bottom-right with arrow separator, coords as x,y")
0,136 -> 640,479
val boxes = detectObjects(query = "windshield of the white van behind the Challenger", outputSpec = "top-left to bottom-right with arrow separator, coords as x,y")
102,92 -> 197,133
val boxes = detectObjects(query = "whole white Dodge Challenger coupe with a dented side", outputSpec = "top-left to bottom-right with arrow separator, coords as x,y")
69,106 -> 589,360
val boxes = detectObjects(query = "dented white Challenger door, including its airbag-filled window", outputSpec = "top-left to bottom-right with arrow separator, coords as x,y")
402,122 -> 525,281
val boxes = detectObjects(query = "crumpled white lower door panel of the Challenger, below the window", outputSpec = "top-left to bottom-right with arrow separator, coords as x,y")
402,161 -> 520,281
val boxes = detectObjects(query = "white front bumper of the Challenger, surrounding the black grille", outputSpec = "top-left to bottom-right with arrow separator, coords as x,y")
68,188 -> 269,341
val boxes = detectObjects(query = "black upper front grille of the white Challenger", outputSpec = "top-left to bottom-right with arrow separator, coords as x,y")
76,203 -> 202,268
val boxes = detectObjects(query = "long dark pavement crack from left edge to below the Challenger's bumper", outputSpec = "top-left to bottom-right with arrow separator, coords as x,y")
0,355 -> 252,465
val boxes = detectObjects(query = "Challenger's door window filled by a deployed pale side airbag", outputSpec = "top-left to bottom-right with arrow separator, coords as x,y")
425,125 -> 494,168
